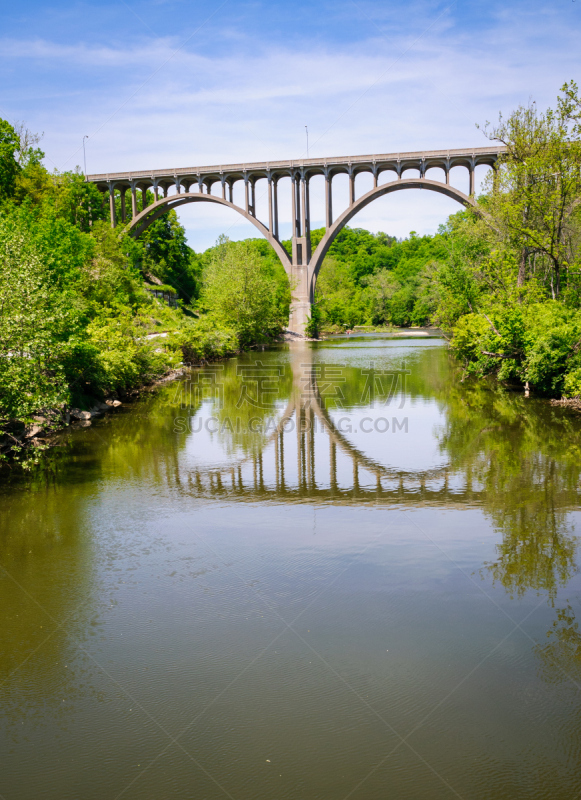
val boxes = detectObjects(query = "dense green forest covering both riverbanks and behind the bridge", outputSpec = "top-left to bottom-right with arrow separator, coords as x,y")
0,82 -> 581,462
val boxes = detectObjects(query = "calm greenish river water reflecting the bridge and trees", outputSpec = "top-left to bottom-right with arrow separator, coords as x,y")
0,337 -> 581,800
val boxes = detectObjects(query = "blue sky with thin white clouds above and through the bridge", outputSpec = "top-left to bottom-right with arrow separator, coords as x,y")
0,0 -> 581,250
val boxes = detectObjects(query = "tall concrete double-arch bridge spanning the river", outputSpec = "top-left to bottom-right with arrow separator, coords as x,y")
87,147 -> 505,334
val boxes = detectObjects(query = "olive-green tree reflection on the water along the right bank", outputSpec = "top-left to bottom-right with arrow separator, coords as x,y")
440,382 -> 581,601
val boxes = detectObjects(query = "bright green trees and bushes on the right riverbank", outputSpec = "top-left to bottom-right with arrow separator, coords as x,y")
436,83 -> 581,396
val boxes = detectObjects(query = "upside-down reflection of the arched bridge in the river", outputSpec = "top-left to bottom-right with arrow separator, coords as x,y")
188,346 -> 482,505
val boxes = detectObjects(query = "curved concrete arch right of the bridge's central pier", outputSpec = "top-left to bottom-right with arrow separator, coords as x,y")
309,178 -> 476,302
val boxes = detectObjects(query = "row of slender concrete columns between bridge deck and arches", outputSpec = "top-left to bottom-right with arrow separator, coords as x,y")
109,163 -> 474,234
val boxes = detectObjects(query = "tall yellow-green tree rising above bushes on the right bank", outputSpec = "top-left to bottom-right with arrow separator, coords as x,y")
476,81 -> 581,299
